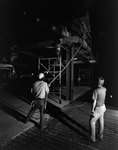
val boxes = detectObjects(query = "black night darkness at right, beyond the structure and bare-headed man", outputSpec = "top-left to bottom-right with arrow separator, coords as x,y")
91,0 -> 118,107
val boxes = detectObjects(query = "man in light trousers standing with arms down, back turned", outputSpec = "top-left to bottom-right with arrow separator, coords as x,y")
89,77 -> 107,142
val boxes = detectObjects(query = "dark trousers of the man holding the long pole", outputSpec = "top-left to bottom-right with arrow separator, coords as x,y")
26,99 -> 45,127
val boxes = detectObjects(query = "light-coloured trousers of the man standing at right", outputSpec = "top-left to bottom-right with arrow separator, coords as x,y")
89,105 -> 106,140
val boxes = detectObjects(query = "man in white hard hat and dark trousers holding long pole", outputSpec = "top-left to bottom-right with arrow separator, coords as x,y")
25,73 -> 49,129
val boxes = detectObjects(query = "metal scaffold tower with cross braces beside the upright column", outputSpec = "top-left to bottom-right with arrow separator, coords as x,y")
38,55 -> 64,103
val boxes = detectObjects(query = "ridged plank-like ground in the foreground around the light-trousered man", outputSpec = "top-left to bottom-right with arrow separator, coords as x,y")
0,102 -> 118,150
